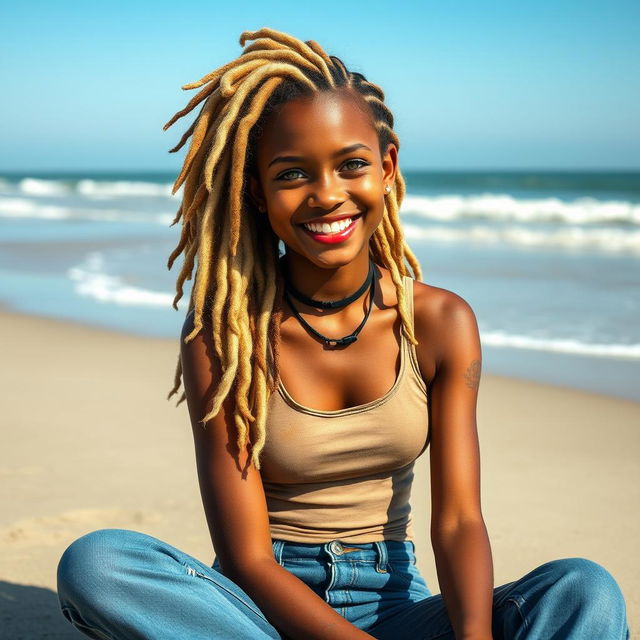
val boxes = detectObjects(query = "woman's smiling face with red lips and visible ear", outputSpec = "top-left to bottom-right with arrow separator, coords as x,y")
250,91 -> 397,267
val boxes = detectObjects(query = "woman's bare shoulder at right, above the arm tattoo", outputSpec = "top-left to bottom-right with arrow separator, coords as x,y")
413,280 -> 480,365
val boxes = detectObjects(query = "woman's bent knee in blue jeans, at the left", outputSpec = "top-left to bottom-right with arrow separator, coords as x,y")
57,529 -> 145,606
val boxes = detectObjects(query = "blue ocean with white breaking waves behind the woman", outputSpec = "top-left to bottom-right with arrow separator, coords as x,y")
0,171 -> 640,400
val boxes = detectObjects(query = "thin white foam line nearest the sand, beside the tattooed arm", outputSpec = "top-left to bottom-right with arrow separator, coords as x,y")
480,331 -> 640,360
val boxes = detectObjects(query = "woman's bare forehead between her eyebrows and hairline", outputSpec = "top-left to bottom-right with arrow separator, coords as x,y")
257,92 -> 378,161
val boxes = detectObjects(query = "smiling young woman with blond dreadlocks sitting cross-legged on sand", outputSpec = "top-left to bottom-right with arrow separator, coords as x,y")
58,28 -> 628,640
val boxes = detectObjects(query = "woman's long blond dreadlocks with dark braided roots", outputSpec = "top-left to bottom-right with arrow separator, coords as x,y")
164,27 -> 422,469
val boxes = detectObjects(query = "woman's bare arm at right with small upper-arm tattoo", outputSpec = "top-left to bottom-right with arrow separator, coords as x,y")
429,290 -> 493,640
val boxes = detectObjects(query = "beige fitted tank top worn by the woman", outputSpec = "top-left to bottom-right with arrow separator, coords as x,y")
261,276 -> 430,544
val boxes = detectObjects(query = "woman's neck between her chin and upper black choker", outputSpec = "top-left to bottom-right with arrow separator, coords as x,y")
281,251 -> 370,311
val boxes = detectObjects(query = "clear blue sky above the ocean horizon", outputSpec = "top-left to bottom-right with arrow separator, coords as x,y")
0,0 -> 640,171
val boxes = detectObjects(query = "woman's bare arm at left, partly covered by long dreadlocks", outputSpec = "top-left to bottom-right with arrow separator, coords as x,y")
180,313 -> 372,640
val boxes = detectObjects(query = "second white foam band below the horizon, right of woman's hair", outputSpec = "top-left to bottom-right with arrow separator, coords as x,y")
403,223 -> 640,254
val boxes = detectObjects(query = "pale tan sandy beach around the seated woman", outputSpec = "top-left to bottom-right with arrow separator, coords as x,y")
0,311 -> 640,640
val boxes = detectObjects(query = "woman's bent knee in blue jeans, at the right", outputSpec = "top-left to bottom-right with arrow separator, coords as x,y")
544,558 -> 625,614
